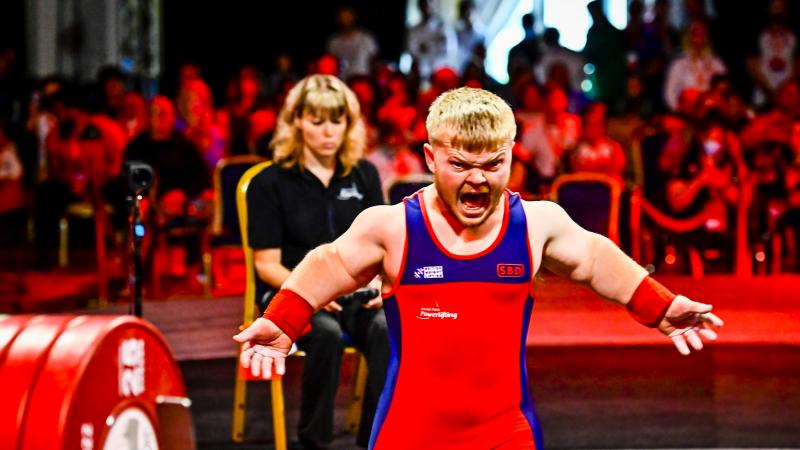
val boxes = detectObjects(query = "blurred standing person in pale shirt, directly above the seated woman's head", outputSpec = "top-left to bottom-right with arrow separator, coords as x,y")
328,7 -> 380,80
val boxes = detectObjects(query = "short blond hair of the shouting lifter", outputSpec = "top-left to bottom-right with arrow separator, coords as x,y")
425,87 -> 517,151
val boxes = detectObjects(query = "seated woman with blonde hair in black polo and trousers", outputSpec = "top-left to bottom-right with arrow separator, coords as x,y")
247,75 -> 389,448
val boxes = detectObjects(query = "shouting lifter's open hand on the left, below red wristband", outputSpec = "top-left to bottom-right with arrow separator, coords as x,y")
233,317 -> 292,379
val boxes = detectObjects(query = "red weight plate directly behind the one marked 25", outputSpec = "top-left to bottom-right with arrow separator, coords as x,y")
0,316 -> 75,449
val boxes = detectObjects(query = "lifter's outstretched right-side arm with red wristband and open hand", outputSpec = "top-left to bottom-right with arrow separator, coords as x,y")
537,202 -> 723,355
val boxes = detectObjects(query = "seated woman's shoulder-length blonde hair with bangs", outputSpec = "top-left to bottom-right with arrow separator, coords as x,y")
270,75 -> 367,175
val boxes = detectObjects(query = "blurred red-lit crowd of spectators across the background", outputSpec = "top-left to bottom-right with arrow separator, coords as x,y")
0,0 -> 800,278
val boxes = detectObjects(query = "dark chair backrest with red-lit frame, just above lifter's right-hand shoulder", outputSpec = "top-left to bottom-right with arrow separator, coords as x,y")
551,172 -> 622,245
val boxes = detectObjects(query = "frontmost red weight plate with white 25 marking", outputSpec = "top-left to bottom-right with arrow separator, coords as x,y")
21,316 -> 186,450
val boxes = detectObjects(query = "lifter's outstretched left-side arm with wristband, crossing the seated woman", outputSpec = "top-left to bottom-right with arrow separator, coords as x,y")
233,206 -> 391,378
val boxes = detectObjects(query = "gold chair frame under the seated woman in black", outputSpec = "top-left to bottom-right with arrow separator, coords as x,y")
232,161 -> 367,450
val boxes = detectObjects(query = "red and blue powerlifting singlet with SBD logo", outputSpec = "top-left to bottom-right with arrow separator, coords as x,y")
370,191 -> 542,450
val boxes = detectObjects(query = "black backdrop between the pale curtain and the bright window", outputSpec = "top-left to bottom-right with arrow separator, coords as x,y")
162,0 -> 406,98
